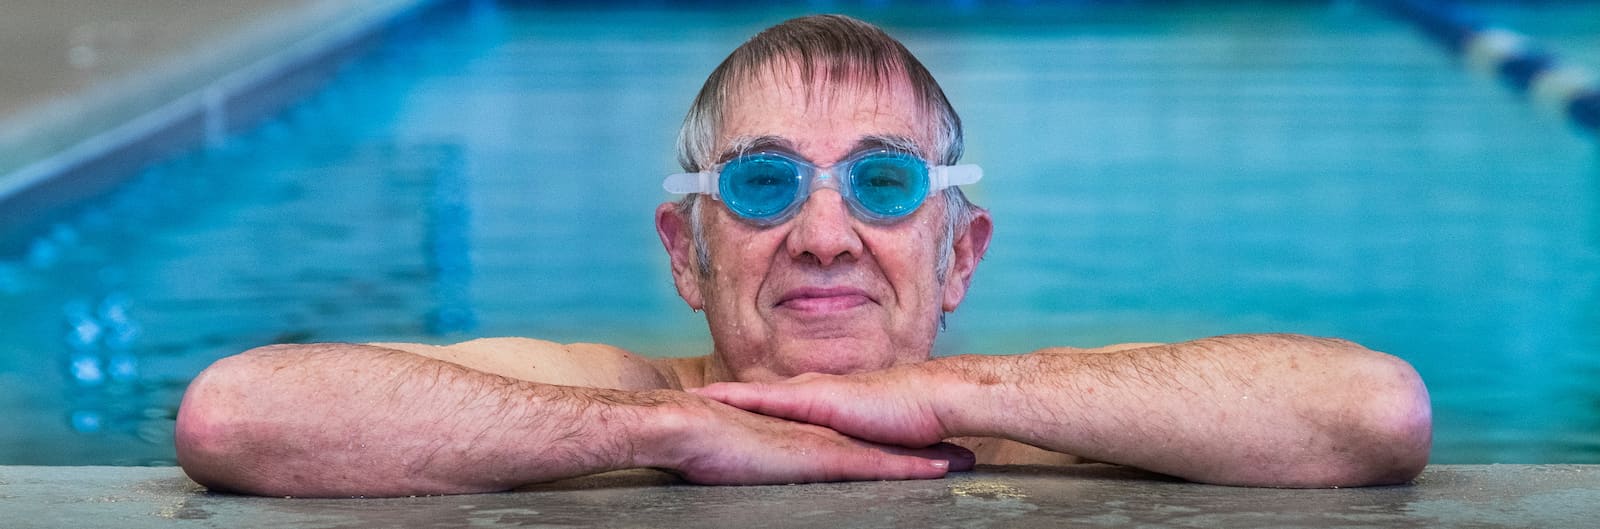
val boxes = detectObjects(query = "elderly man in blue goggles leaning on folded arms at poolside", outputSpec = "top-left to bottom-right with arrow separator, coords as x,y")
178,16 -> 1432,495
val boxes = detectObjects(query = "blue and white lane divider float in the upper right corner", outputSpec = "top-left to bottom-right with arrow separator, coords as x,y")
1374,0 -> 1600,136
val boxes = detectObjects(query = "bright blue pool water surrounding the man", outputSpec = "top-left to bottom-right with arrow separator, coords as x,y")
0,3 -> 1600,463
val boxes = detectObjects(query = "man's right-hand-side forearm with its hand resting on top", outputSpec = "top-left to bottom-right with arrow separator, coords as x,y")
698,336 -> 1432,486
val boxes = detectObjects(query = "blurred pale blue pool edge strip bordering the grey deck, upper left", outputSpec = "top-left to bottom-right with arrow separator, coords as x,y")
0,0 -> 458,257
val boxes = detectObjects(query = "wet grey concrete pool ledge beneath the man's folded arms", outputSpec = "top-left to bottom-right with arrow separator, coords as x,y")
0,465 -> 1600,527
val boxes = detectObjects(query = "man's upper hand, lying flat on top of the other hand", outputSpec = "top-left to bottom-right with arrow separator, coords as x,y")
690,364 -> 954,447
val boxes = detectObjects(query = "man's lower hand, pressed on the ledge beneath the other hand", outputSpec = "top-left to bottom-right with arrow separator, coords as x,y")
643,392 -> 974,484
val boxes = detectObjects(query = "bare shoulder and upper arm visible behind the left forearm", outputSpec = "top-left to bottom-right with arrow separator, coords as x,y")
371,337 -> 682,390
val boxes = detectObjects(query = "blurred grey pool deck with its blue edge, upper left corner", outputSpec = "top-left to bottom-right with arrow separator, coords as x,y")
0,0 -> 435,251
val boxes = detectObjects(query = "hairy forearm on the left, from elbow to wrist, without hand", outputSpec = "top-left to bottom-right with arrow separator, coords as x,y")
178,344 -> 664,495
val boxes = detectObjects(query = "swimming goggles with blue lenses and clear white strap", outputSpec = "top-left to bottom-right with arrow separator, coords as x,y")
662,149 -> 984,225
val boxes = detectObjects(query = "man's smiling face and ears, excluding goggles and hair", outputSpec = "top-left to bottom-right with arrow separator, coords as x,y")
658,66 -> 987,380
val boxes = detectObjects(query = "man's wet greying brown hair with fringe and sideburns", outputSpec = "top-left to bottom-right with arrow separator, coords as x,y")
677,14 -> 978,290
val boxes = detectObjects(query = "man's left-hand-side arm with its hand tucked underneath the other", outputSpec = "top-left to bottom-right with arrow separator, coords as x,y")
176,340 -> 970,495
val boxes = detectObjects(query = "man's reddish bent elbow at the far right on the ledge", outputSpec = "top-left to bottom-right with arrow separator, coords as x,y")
1330,352 -> 1434,486
